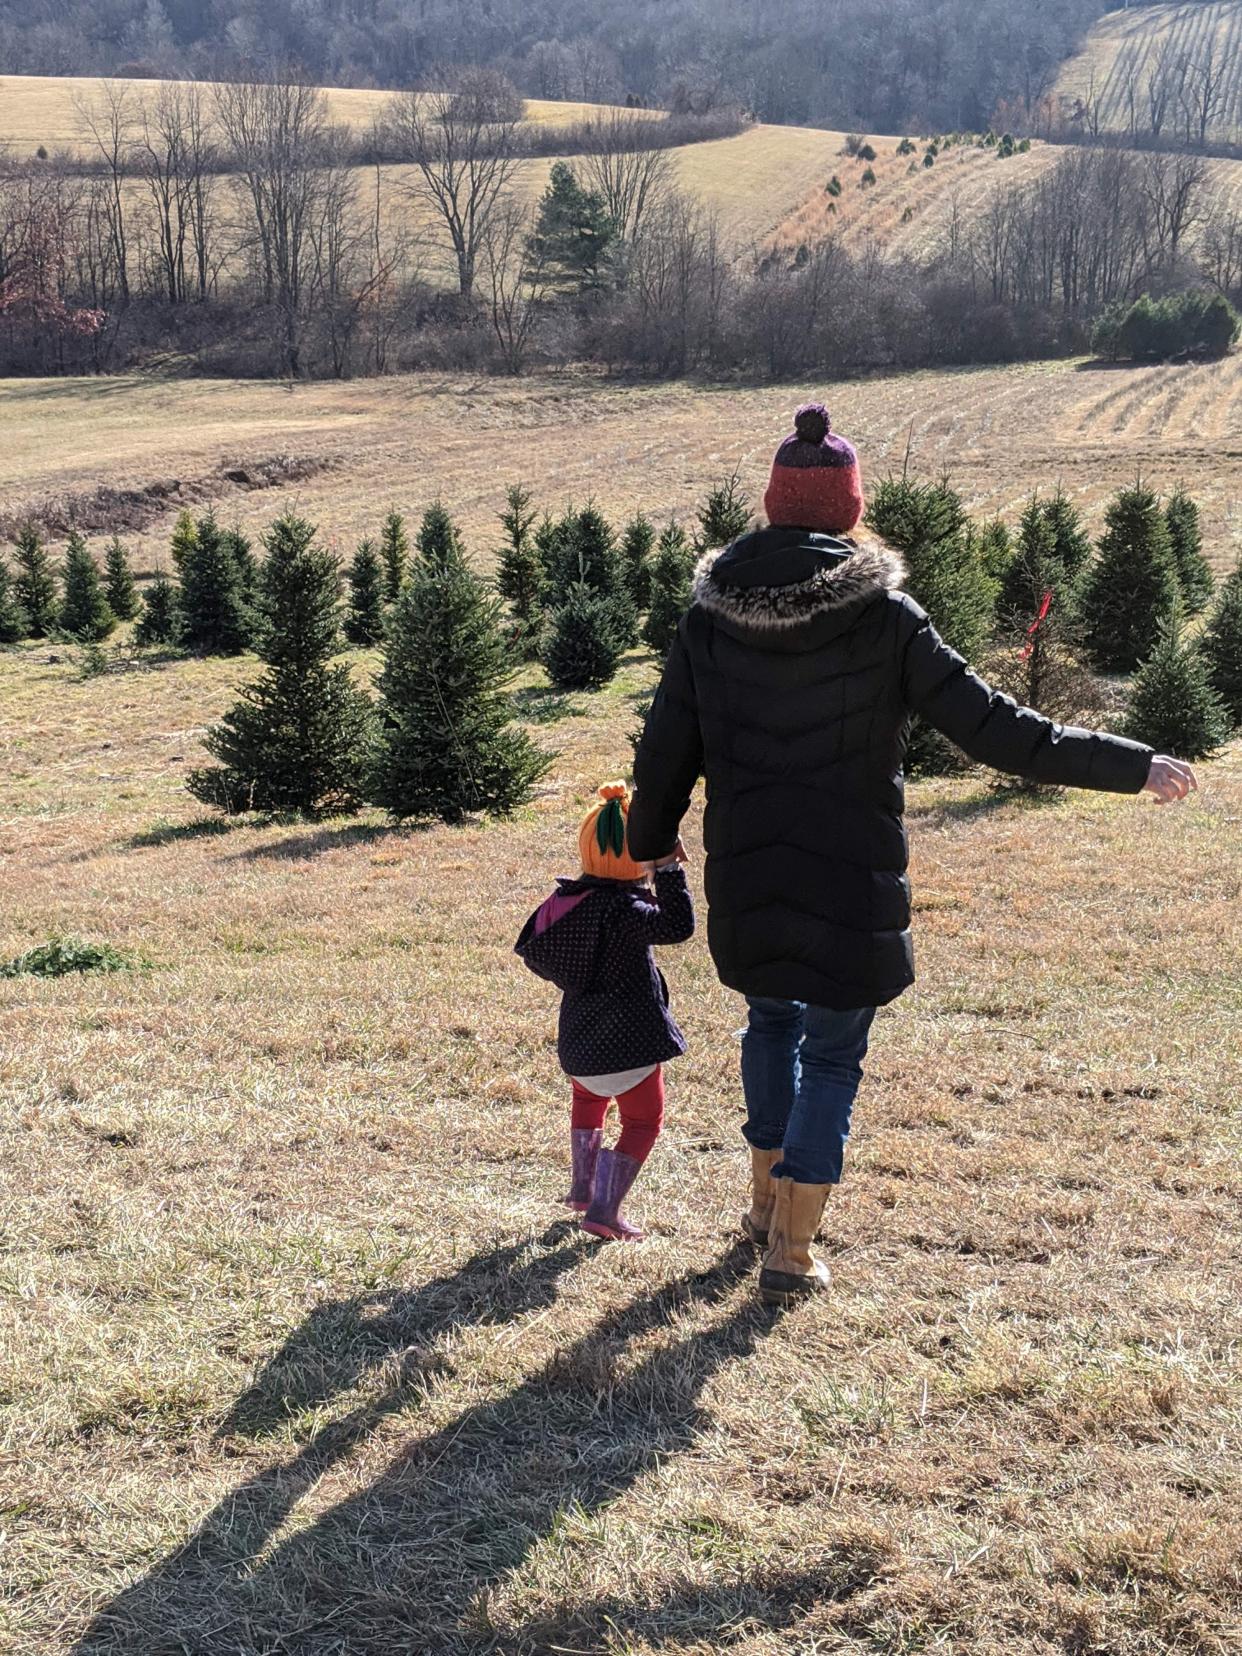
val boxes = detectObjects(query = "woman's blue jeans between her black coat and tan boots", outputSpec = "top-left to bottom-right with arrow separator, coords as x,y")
742,997 -> 876,1184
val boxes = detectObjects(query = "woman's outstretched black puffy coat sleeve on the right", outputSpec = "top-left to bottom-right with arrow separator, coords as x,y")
901,598 -> 1153,793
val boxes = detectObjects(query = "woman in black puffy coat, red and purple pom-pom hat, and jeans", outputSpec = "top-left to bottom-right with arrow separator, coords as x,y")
629,411 -> 1194,1302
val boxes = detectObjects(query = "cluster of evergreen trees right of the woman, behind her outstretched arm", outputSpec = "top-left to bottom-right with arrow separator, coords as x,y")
868,479 -> 1242,770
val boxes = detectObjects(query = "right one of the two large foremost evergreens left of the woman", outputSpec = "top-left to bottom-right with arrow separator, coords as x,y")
373,533 -> 548,821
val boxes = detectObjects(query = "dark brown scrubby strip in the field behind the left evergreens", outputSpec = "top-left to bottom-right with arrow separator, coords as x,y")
0,454 -> 339,540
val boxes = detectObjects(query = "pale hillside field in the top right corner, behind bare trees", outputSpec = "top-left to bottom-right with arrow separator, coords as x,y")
1057,0 -> 1242,141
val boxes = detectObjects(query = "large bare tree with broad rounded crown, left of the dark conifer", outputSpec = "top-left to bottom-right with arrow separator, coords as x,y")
386,73 -> 518,300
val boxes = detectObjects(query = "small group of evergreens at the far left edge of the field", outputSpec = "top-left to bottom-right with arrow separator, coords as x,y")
0,523 -> 137,644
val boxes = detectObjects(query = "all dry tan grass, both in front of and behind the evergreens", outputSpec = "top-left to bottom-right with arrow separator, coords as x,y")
0,364 -> 1242,1656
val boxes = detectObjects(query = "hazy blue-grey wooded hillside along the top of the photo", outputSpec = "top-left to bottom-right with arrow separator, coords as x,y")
0,0 -> 1108,132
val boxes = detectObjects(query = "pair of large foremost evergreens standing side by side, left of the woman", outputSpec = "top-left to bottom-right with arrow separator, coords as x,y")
189,507 -> 548,821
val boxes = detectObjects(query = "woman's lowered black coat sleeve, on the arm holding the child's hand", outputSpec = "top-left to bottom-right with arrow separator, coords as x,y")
628,621 -> 702,863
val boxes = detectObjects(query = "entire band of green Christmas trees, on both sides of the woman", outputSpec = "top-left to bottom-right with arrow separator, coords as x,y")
0,477 -> 1242,821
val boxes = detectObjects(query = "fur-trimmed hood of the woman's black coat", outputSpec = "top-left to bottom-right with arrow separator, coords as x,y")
692,528 -> 906,633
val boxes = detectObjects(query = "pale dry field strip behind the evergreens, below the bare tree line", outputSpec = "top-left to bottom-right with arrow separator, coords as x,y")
0,356 -> 1242,568
